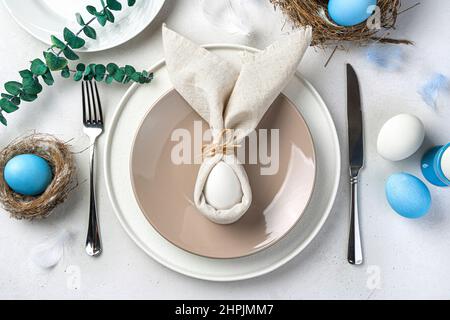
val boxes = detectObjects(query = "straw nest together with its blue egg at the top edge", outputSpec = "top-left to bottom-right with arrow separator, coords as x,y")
270,0 -> 412,47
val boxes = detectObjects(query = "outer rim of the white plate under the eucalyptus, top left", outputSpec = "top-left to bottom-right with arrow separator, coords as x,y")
2,0 -> 166,53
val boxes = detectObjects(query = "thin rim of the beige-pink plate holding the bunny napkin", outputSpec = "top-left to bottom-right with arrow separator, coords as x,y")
128,88 -> 317,260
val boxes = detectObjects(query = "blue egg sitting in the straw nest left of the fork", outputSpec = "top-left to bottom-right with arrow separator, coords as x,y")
3,154 -> 53,196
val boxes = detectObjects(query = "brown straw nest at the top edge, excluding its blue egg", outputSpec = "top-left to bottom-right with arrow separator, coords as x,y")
270,0 -> 411,47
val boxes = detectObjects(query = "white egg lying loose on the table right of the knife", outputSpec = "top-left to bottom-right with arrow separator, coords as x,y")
377,114 -> 425,161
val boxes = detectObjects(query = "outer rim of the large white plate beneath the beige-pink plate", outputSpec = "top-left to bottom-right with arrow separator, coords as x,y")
103,43 -> 342,282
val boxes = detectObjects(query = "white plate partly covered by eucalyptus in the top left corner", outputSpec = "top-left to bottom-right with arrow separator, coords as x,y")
3,0 -> 165,52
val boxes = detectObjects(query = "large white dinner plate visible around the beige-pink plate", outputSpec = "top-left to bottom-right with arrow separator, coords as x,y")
104,45 -> 341,281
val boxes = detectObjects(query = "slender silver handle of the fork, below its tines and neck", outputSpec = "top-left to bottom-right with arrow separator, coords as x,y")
86,139 -> 102,257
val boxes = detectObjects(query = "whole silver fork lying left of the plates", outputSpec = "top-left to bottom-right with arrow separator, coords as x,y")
81,81 -> 103,257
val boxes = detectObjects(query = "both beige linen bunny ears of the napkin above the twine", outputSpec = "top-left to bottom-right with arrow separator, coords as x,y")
163,24 -> 312,140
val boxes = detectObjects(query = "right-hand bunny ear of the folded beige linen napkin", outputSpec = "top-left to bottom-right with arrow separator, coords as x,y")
225,27 -> 312,141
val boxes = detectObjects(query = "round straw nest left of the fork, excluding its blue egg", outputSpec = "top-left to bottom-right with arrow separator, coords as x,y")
0,134 -> 76,220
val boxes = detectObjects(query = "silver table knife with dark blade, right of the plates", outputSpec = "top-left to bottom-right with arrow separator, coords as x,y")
347,64 -> 364,265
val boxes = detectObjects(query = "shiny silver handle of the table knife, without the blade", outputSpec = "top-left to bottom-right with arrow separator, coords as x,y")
347,175 -> 363,265
